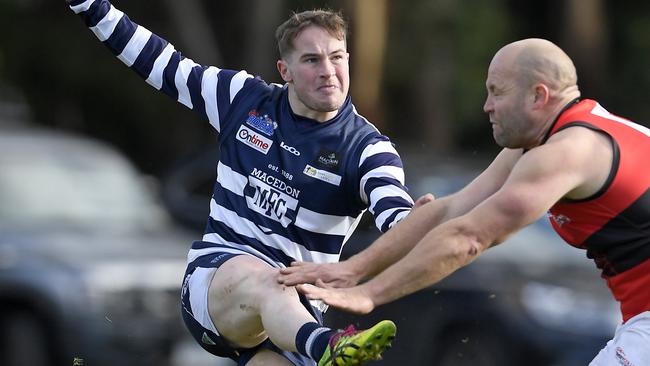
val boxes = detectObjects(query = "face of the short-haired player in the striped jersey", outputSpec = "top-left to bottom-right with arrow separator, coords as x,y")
278,26 -> 350,121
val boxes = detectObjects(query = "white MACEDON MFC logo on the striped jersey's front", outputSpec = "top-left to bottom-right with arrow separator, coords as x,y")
246,168 -> 300,227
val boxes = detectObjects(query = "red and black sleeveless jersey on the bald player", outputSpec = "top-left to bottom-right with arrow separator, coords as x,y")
547,99 -> 650,321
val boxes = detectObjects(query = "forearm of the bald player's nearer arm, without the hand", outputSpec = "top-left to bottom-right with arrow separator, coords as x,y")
364,183 -> 544,306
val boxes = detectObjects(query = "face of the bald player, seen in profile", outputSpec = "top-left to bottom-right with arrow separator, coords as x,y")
483,57 -> 531,148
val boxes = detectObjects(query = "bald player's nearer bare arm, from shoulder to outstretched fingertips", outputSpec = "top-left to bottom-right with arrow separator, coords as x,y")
298,129 -> 609,313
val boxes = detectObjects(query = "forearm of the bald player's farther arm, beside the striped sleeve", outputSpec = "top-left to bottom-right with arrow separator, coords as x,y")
348,198 -> 450,278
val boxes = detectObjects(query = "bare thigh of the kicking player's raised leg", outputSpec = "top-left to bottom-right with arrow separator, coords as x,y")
208,255 -> 278,348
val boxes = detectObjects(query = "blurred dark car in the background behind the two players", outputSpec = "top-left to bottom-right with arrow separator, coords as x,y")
158,149 -> 621,366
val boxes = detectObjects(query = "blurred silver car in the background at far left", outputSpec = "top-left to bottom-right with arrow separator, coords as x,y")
0,126 -> 204,366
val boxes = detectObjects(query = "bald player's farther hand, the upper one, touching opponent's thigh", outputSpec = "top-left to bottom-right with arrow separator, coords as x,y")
278,261 -> 360,287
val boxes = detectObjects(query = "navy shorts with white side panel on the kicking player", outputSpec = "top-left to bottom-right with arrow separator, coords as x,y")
181,253 -> 323,366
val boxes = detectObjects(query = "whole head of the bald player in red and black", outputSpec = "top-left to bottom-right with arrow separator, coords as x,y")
483,38 -> 580,148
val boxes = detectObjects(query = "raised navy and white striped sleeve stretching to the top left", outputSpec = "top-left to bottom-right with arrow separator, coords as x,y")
70,0 -> 253,132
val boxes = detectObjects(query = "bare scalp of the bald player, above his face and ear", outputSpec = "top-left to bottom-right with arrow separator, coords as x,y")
491,38 -> 580,99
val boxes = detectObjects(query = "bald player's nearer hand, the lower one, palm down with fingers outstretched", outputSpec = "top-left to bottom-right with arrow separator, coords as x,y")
296,280 -> 375,314
